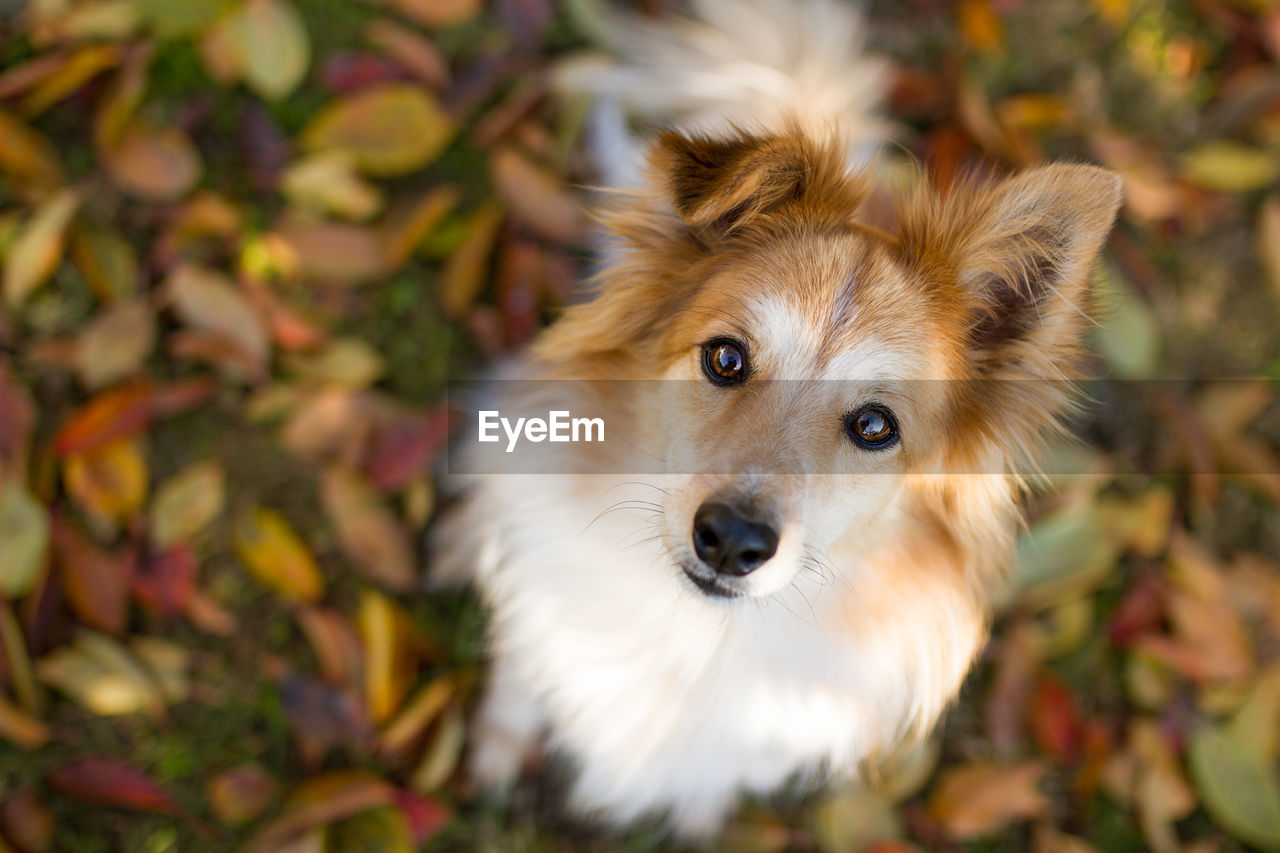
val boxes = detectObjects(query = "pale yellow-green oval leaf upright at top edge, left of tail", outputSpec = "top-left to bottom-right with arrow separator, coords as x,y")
225,0 -> 311,101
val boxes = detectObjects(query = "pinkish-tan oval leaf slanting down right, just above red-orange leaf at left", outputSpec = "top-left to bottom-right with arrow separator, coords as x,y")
164,264 -> 271,368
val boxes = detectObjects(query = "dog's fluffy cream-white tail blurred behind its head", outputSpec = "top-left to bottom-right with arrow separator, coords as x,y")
557,0 -> 887,186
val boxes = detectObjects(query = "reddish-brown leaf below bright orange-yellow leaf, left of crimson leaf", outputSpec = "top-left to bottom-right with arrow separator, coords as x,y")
54,516 -> 137,635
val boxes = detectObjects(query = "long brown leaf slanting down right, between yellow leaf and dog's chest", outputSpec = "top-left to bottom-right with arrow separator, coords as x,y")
321,467 -> 419,591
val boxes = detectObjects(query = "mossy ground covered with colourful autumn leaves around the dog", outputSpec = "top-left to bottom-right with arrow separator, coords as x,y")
0,0 -> 1280,853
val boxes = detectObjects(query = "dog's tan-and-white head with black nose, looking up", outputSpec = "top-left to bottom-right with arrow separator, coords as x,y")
538,133 -> 1120,597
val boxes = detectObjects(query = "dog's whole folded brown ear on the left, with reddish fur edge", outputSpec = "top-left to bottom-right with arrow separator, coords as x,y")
650,131 -> 863,233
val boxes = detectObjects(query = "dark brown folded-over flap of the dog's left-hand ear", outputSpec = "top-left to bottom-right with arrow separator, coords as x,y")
653,131 -> 812,231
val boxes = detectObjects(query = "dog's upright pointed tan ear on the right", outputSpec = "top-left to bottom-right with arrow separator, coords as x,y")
901,165 -> 1121,377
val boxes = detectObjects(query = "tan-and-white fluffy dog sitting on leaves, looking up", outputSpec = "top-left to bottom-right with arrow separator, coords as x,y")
435,0 -> 1121,840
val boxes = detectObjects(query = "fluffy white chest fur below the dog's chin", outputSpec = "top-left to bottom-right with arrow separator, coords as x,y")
455,478 -> 947,835
